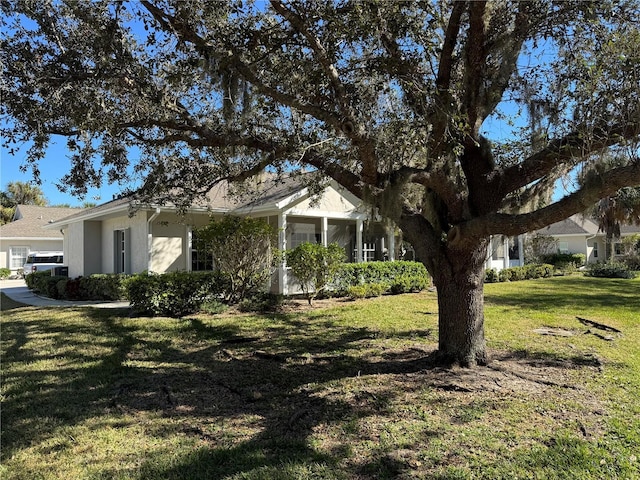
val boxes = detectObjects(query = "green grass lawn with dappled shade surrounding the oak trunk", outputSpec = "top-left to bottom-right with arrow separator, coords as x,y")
0,276 -> 640,480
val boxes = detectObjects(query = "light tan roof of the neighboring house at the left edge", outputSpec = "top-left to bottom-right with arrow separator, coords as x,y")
0,205 -> 82,238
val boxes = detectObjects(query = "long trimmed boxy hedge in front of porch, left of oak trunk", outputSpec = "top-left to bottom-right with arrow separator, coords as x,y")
331,261 -> 429,296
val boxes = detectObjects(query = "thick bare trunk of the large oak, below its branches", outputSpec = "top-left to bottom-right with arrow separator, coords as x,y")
434,241 -> 487,367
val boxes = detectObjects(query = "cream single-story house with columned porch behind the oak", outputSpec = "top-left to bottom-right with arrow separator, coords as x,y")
46,178 -> 397,294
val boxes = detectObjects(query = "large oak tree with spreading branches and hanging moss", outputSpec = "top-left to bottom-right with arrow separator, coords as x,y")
2,0 -> 640,365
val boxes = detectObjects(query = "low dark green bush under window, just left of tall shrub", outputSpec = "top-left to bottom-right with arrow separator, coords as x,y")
127,272 -> 229,318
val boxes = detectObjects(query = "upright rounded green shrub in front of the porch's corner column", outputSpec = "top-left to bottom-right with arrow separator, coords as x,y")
286,242 -> 345,305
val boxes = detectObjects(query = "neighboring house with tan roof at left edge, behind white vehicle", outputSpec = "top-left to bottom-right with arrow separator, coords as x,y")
0,205 -> 81,275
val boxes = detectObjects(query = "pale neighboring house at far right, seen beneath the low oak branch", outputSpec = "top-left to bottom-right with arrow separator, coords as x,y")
536,214 -> 640,263
